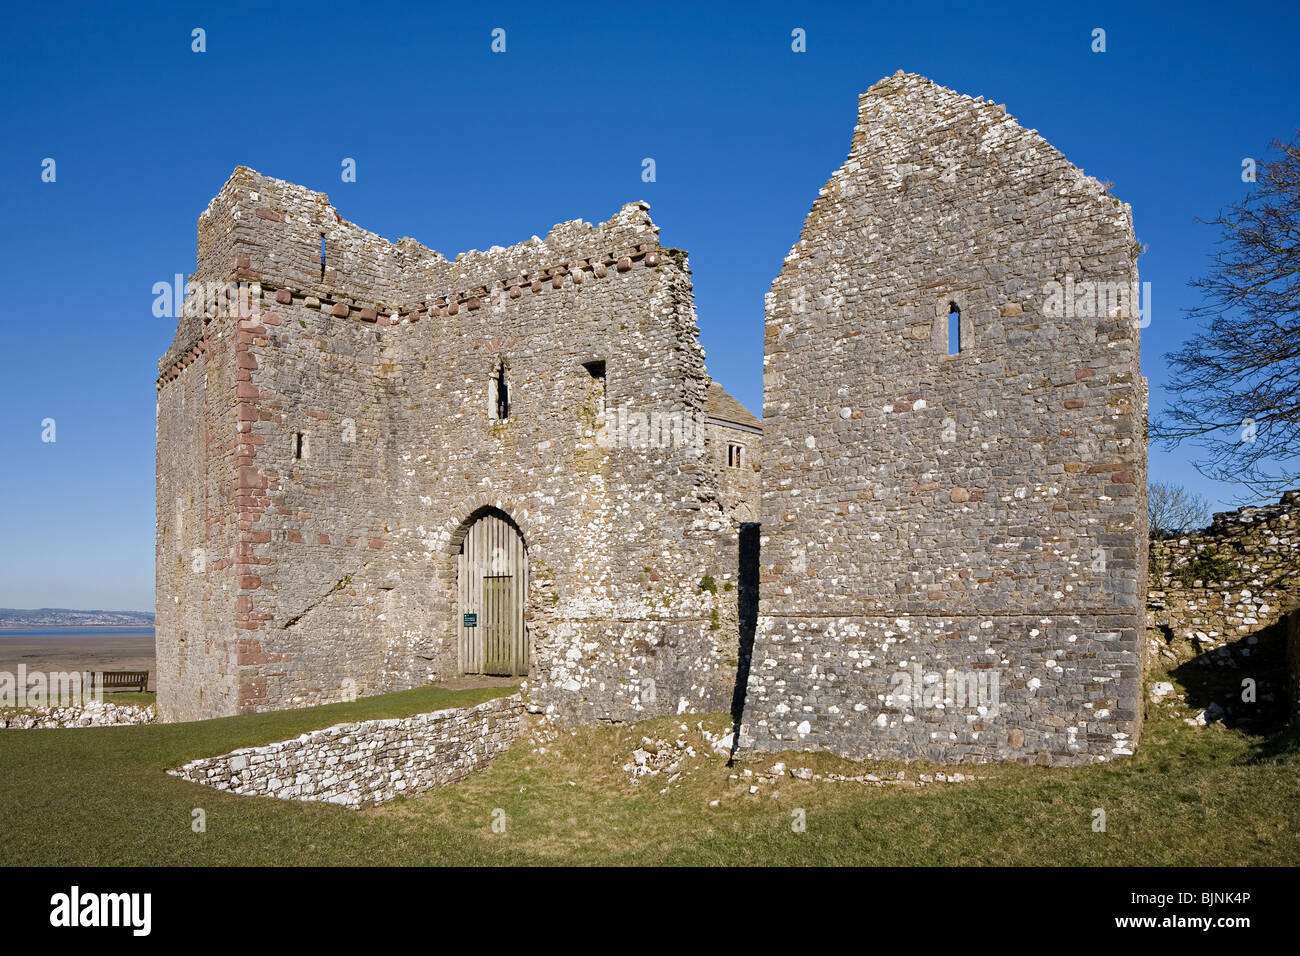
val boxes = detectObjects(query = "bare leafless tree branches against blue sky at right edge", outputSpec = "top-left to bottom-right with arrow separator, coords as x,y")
1152,130 -> 1300,496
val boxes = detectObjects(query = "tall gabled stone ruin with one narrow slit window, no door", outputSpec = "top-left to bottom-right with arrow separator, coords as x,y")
741,73 -> 1147,763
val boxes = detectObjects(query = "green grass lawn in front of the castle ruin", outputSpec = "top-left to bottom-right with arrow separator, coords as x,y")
0,675 -> 1300,866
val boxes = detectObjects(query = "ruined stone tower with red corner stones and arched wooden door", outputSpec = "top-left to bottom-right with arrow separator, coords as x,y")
156,168 -> 757,719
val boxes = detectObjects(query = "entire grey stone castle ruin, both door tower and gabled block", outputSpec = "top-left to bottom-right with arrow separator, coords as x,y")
157,73 -> 1147,762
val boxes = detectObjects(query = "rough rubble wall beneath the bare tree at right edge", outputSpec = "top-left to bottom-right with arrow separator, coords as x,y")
1147,490 -> 1300,666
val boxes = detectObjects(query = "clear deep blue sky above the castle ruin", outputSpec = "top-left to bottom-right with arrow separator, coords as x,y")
0,0 -> 1300,610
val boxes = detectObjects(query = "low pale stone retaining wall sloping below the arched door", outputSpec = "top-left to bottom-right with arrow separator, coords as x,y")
168,695 -> 524,808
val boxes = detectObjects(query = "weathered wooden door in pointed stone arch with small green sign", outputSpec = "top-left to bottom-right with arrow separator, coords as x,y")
456,509 -> 528,676
